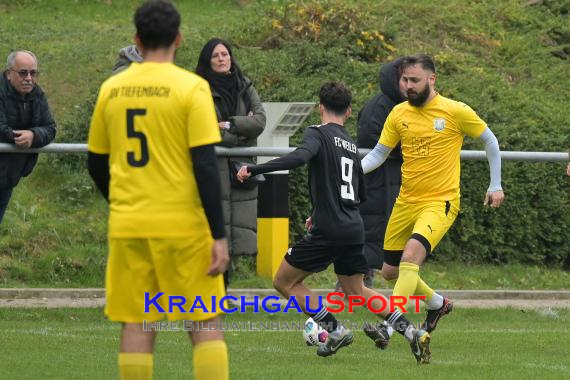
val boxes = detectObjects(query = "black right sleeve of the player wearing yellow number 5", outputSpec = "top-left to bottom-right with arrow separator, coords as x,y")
190,145 -> 226,239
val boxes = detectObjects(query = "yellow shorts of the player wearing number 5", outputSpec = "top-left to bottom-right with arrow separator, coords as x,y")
105,238 -> 226,323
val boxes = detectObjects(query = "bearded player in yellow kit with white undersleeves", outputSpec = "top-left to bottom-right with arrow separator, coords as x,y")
362,54 -> 504,332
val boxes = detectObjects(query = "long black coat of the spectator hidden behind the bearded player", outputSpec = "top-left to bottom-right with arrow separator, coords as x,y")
357,59 -> 405,268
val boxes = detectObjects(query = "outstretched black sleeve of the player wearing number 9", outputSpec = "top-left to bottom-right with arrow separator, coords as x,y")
247,127 -> 321,175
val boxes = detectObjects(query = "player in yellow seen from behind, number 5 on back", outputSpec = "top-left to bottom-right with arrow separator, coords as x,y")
88,1 -> 229,379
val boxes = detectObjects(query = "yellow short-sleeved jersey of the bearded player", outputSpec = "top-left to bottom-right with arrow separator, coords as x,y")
379,94 -> 487,202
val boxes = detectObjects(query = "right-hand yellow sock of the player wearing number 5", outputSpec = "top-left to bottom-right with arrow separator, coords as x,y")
192,340 -> 230,380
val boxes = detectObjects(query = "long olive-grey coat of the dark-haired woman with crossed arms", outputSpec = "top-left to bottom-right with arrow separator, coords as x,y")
212,78 -> 266,255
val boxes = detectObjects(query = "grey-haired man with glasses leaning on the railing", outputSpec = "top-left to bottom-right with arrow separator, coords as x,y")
0,50 -> 55,223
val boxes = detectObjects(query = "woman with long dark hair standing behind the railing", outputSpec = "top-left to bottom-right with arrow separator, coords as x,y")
196,38 -> 265,286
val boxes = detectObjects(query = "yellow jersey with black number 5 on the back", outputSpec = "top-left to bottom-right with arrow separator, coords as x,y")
88,62 -> 220,238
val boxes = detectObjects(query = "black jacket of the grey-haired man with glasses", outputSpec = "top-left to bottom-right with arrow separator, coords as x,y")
0,75 -> 56,189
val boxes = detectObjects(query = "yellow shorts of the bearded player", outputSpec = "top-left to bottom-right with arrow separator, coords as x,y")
384,197 -> 459,254
